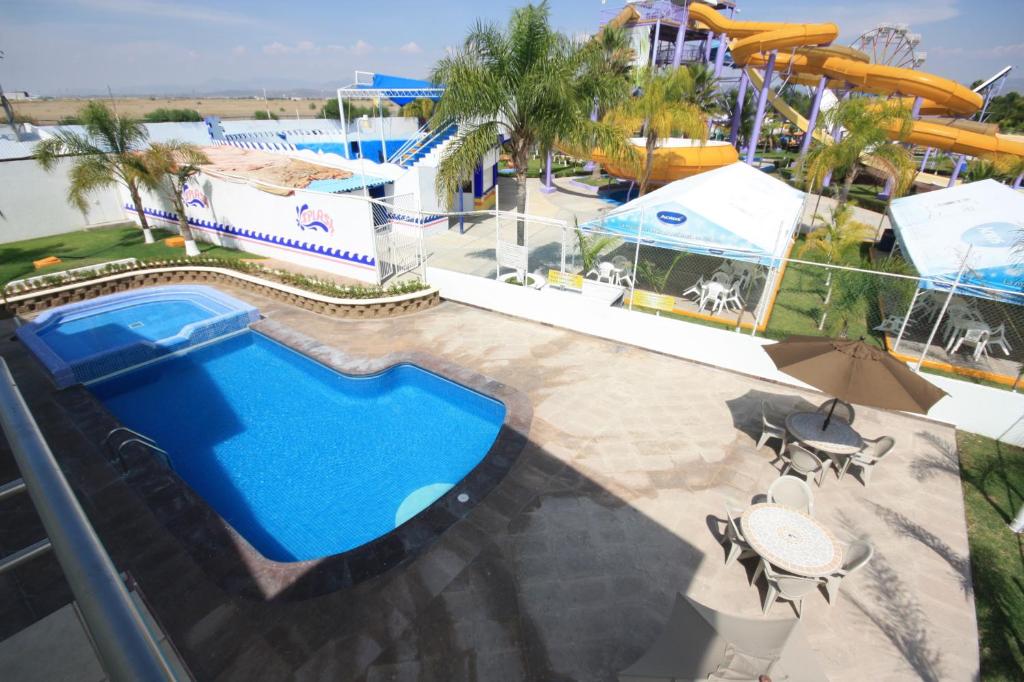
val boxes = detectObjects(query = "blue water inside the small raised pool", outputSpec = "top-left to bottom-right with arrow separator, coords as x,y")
39,300 -> 222,363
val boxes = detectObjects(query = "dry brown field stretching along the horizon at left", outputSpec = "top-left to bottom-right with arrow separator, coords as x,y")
11,97 -> 385,125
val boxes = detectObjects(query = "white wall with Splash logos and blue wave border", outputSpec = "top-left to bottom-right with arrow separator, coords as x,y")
123,175 -> 378,284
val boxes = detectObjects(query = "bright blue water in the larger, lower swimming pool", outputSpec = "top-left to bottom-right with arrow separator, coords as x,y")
90,331 -> 505,561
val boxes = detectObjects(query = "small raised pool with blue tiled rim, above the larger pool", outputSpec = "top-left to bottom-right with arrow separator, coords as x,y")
17,285 -> 259,388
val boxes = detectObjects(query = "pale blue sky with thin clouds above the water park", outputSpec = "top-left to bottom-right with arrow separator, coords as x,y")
0,0 -> 1024,95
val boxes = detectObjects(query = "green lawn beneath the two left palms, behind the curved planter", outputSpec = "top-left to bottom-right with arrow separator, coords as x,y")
0,223 -> 260,284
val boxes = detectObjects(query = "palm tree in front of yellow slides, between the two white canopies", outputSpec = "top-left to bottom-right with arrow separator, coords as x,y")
799,97 -> 914,204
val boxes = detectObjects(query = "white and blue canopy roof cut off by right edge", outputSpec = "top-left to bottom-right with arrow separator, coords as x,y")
889,180 -> 1024,304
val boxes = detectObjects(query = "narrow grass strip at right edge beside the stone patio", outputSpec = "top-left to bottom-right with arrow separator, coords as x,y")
956,433 -> 1024,681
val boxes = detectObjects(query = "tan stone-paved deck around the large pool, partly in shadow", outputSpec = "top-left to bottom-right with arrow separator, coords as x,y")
0,287 -> 978,681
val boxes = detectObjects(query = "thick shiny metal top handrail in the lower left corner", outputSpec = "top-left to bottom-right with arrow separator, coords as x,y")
0,358 -> 175,682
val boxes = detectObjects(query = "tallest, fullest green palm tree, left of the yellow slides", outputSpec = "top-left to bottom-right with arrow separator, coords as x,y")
431,2 -> 624,244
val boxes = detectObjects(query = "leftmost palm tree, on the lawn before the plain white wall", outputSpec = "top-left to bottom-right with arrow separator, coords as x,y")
33,101 -> 154,244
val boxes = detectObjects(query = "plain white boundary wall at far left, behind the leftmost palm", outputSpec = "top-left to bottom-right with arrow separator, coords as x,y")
0,159 -> 125,244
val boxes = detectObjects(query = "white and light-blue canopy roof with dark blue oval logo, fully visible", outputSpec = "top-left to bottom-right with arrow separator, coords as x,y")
587,163 -> 804,264
